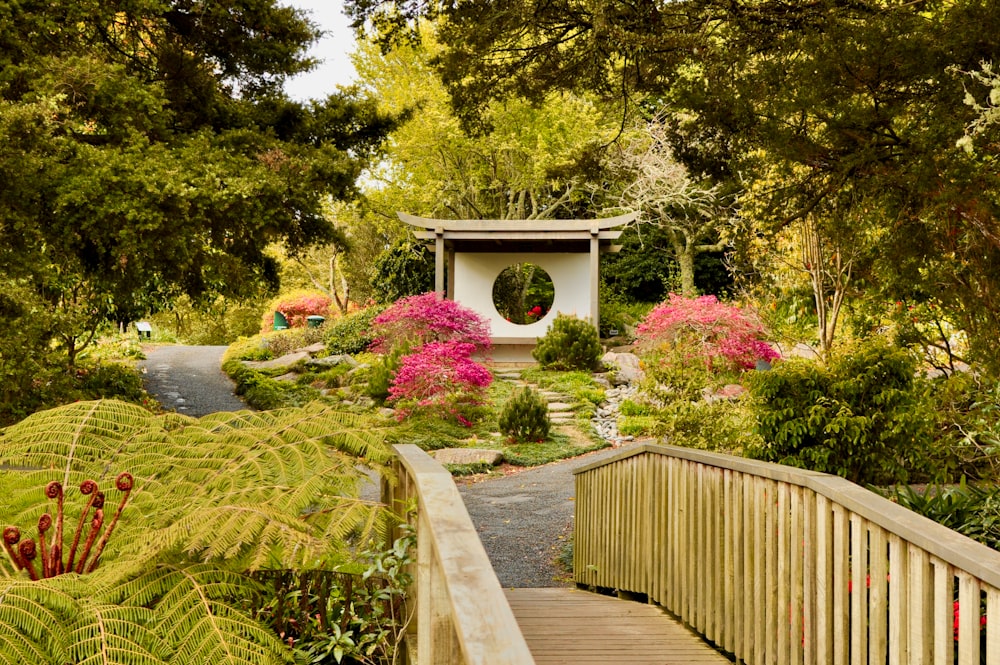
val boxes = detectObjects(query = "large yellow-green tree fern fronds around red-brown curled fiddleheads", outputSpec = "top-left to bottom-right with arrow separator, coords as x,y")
0,400 -> 388,665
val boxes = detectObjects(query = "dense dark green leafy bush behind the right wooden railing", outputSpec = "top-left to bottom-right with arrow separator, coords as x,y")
747,339 -> 932,483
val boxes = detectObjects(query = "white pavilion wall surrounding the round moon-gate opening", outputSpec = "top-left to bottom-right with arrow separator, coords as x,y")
454,252 -> 593,342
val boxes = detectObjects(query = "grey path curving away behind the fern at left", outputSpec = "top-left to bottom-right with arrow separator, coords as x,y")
139,345 -> 248,417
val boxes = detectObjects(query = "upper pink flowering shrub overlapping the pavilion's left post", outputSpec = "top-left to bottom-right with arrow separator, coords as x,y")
370,292 -> 490,353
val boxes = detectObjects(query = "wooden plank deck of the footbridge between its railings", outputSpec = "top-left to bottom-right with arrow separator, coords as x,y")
506,589 -> 730,665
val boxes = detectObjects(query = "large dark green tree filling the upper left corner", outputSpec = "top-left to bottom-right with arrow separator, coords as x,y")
0,0 -> 391,363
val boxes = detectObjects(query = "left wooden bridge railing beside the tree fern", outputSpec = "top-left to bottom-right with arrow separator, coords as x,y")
383,445 -> 535,665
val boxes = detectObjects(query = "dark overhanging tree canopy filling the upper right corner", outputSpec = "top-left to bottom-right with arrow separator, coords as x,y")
348,0 -> 1000,367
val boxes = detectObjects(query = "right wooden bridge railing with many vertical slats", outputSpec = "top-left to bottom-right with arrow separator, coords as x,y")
574,445 -> 1000,665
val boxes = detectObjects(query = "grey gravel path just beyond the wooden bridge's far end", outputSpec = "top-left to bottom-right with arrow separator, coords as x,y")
458,449 -> 636,588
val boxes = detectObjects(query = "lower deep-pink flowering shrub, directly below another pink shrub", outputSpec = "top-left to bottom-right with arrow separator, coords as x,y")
389,341 -> 493,425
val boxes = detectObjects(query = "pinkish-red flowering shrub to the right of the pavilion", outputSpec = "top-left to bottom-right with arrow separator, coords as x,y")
636,293 -> 778,369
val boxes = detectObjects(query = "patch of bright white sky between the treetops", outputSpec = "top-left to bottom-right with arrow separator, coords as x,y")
281,0 -> 355,101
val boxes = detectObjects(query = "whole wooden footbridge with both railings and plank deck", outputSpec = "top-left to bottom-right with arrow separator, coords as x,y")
384,445 -> 1000,665
